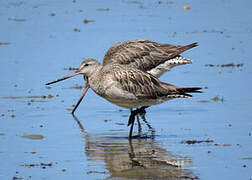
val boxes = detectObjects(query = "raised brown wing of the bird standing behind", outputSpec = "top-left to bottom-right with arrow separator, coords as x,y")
103,39 -> 197,71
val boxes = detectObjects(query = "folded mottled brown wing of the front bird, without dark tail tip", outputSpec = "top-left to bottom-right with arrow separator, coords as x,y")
113,65 -> 177,99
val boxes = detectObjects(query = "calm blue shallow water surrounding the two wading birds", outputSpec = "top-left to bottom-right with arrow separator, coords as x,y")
0,0 -> 252,179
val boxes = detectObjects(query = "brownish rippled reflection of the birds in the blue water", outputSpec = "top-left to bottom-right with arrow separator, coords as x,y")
71,115 -> 198,179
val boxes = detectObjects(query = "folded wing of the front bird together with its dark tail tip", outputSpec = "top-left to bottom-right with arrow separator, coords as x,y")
108,65 -> 201,99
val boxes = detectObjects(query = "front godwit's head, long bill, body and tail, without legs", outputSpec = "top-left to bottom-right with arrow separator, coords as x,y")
48,59 -> 200,109
